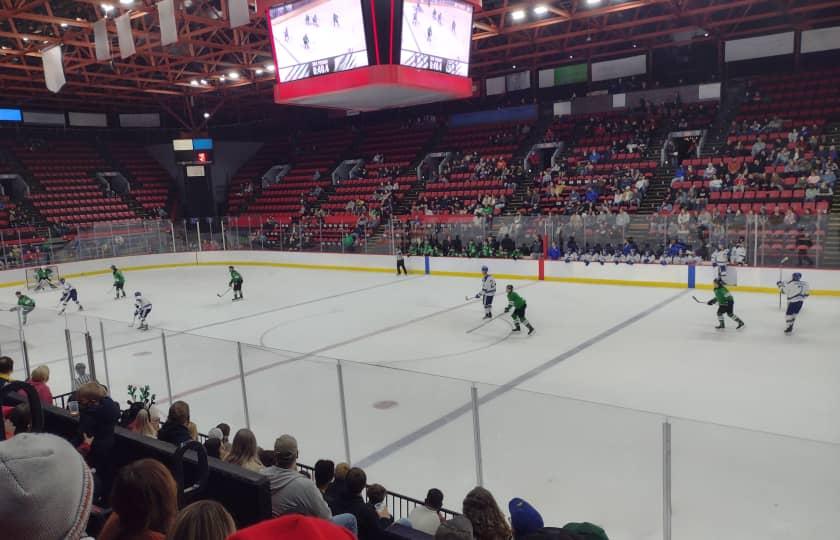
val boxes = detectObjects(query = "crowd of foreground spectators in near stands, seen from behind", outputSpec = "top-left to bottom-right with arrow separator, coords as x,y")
0,357 -> 608,540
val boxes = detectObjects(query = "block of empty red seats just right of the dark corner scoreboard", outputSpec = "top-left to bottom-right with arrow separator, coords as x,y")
247,128 -> 354,215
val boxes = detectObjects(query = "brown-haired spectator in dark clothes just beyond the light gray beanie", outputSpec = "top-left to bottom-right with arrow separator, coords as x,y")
75,382 -> 120,495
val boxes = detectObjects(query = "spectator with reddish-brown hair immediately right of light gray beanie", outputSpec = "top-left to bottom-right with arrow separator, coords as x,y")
98,459 -> 178,540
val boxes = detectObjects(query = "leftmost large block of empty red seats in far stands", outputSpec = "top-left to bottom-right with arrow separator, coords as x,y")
14,140 -> 137,224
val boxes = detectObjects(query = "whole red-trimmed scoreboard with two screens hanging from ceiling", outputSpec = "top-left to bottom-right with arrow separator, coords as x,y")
258,0 -> 481,110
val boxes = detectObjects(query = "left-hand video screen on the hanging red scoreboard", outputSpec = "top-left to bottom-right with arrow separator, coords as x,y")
269,0 -> 368,83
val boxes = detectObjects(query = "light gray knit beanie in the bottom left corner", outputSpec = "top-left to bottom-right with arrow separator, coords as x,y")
0,433 -> 93,540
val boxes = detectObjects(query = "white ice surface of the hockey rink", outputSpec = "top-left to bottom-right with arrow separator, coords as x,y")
0,266 -> 840,540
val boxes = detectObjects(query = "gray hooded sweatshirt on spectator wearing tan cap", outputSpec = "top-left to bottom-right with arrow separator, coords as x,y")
260,467 -> 332,519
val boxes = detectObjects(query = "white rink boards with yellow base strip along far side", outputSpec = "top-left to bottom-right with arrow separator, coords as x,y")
0,251 -> 840,296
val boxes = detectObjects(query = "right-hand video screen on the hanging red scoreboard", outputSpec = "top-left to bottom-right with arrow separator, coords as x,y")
400,0 -> 473,77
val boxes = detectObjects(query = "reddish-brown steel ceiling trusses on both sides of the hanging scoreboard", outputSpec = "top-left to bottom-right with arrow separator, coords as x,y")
0,0 -> 840,126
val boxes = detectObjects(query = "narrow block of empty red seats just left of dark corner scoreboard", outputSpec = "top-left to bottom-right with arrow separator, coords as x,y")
109,143 -> 172,210
